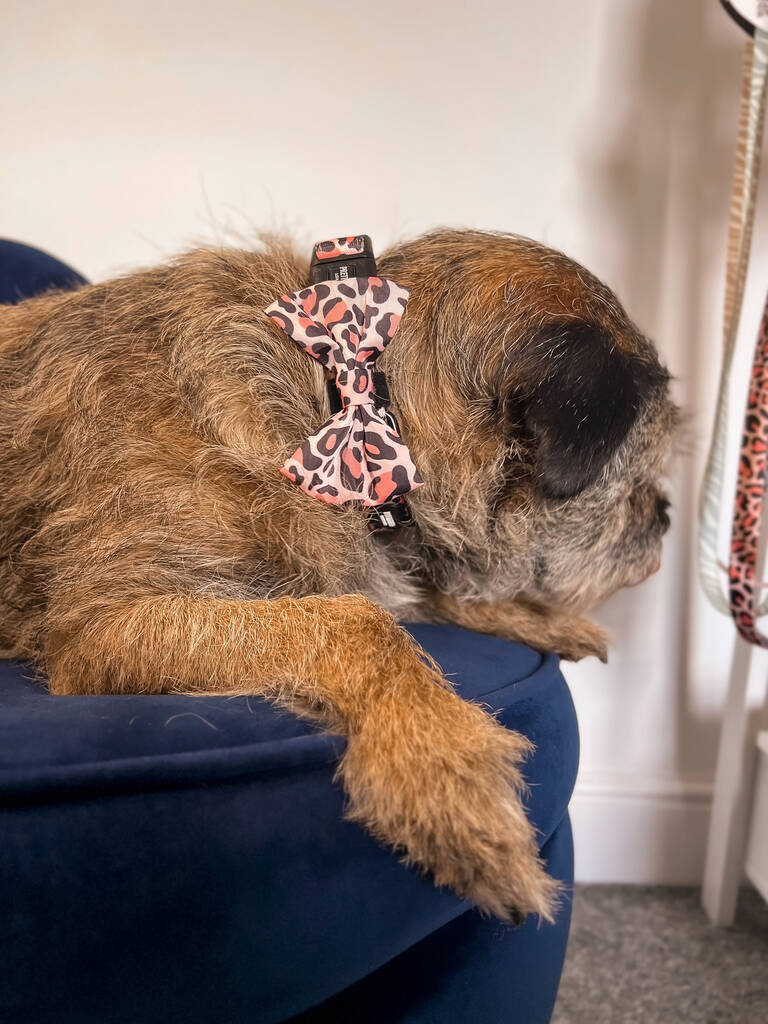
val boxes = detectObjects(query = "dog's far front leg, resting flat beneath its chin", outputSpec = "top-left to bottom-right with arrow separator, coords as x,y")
429,592 -> 608,662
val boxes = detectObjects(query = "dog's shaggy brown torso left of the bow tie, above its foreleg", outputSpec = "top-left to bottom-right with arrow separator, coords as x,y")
0,250 -> 360,655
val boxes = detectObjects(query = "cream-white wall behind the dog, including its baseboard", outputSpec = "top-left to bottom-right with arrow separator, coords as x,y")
0,0 -> 768,881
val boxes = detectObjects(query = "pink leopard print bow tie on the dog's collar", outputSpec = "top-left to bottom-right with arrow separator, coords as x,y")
265,278 -> 423,507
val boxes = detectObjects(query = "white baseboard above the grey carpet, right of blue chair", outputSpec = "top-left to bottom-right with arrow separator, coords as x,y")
570,771 -> 713,886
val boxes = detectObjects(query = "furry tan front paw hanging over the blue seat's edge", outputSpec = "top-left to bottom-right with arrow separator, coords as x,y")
341,690 -> 560,923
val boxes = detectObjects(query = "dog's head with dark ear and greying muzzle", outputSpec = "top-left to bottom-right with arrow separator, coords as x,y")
379,231 -> 677,609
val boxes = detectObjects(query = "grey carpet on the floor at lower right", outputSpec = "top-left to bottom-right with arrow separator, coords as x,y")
552,886 -> 768,1024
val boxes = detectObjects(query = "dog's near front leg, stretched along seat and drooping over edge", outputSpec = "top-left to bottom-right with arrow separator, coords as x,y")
45,596 -> 558,920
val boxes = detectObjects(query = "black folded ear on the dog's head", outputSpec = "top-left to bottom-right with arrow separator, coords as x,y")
516,322 -> 668,500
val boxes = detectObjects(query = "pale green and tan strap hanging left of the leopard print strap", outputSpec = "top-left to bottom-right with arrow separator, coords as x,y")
698,29 -> 768,615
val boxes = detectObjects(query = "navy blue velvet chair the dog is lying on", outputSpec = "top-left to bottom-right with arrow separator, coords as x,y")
0,243 -> 579,1024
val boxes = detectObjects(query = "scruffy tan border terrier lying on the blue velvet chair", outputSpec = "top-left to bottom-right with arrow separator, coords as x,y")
0,230 -> 676,921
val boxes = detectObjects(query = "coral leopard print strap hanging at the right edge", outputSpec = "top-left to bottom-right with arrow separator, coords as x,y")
728,288 -> 768,647
